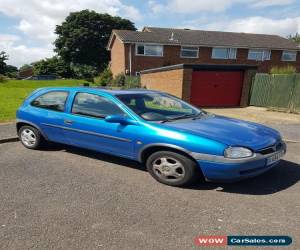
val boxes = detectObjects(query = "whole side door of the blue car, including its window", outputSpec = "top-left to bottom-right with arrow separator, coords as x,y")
64,92 -> 137,158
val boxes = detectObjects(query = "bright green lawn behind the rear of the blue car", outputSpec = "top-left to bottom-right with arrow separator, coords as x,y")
0,79 -> 90,122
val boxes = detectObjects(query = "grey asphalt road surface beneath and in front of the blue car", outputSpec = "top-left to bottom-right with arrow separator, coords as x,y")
0,142 -> 300,249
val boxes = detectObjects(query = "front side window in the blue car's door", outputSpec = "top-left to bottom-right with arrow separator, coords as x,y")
72,93 -> 125,118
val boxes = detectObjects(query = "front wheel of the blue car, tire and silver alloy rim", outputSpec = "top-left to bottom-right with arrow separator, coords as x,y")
146,151 -> 199,187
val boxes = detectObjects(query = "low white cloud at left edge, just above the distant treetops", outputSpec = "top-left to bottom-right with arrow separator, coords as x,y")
0,34 -> 54,67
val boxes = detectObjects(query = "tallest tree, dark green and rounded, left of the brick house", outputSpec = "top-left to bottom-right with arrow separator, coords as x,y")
54,10 -> 136,70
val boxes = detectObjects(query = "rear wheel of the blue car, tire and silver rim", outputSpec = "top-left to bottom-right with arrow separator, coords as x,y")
18,126 -> 44,149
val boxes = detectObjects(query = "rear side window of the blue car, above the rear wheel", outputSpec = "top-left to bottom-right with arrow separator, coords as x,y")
31,91 -> 69,112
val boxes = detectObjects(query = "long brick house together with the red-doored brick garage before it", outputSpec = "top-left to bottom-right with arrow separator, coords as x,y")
107,27 -> 300,106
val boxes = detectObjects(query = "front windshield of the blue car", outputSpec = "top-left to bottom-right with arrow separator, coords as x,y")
117,93 -> 203,122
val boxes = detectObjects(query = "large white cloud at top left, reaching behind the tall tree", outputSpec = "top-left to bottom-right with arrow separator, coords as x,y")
0,0 -> 142,41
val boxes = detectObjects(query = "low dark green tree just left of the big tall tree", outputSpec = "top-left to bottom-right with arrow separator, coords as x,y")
33,56 -> 72,78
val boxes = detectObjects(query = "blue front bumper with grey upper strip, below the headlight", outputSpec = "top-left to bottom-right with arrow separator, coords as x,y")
192,143 -> 286,182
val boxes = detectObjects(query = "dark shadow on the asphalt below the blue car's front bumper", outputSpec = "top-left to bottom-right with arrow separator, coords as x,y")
190,160 -> 300,195
